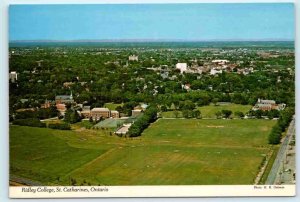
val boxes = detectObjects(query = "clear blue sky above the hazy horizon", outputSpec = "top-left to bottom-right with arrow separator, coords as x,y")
9,3 -> 295,41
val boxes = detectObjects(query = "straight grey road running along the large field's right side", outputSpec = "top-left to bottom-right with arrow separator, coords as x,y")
265,116 -> 295,184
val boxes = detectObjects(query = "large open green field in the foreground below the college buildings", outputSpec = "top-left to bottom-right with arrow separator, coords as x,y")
10,119 -> 276,185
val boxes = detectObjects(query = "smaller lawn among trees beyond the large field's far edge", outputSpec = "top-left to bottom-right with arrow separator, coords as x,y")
162,103 -> 252,118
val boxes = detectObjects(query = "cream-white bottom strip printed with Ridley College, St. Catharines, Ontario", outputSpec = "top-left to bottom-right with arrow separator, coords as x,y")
9,185 -> 296,198
